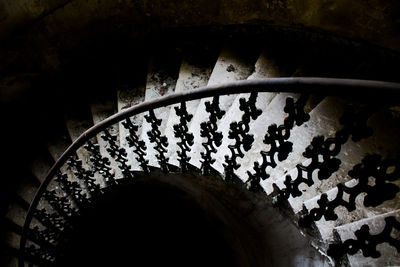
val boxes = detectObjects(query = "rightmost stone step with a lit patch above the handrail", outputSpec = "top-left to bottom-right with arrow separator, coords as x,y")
213,49 -> 287,174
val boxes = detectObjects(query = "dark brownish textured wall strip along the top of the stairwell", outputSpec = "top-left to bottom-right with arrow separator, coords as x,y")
0,0 -> 400,50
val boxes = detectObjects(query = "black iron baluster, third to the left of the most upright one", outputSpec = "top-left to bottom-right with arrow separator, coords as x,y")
101,130 -> 133,178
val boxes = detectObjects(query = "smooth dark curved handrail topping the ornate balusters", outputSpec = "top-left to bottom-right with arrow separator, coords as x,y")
19,77 -> 400,267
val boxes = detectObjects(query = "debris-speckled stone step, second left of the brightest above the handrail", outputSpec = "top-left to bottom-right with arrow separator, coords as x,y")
140,51 -> 180,167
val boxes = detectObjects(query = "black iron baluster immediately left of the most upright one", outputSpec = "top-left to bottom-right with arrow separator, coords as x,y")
144,110 -> 169,173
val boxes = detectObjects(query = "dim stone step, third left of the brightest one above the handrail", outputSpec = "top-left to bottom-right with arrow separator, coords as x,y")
117,87 -> 146,171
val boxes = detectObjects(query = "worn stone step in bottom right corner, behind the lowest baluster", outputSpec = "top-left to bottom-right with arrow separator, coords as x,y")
335,210 -> 400,267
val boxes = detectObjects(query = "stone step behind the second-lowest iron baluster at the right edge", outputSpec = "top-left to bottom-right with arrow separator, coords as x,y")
298,112 -> 400,242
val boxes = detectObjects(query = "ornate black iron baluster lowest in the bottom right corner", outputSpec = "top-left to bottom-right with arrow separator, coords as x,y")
328,216 -> 400,259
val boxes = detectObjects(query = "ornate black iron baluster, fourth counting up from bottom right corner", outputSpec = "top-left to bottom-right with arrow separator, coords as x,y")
247,95 -> 310,191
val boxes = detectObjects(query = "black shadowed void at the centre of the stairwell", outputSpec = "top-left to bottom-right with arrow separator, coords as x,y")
58,184 -> 242,266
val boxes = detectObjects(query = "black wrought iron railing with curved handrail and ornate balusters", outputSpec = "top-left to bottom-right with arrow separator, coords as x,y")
19,78 -> 400,267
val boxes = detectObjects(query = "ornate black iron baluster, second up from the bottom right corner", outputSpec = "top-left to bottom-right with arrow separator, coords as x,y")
299,155 -> 400,227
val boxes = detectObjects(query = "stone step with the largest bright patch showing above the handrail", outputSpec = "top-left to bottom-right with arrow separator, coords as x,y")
189,46 -> 258,168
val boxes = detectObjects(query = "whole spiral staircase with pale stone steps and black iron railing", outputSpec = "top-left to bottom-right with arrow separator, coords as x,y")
3,30 -> 400,266
